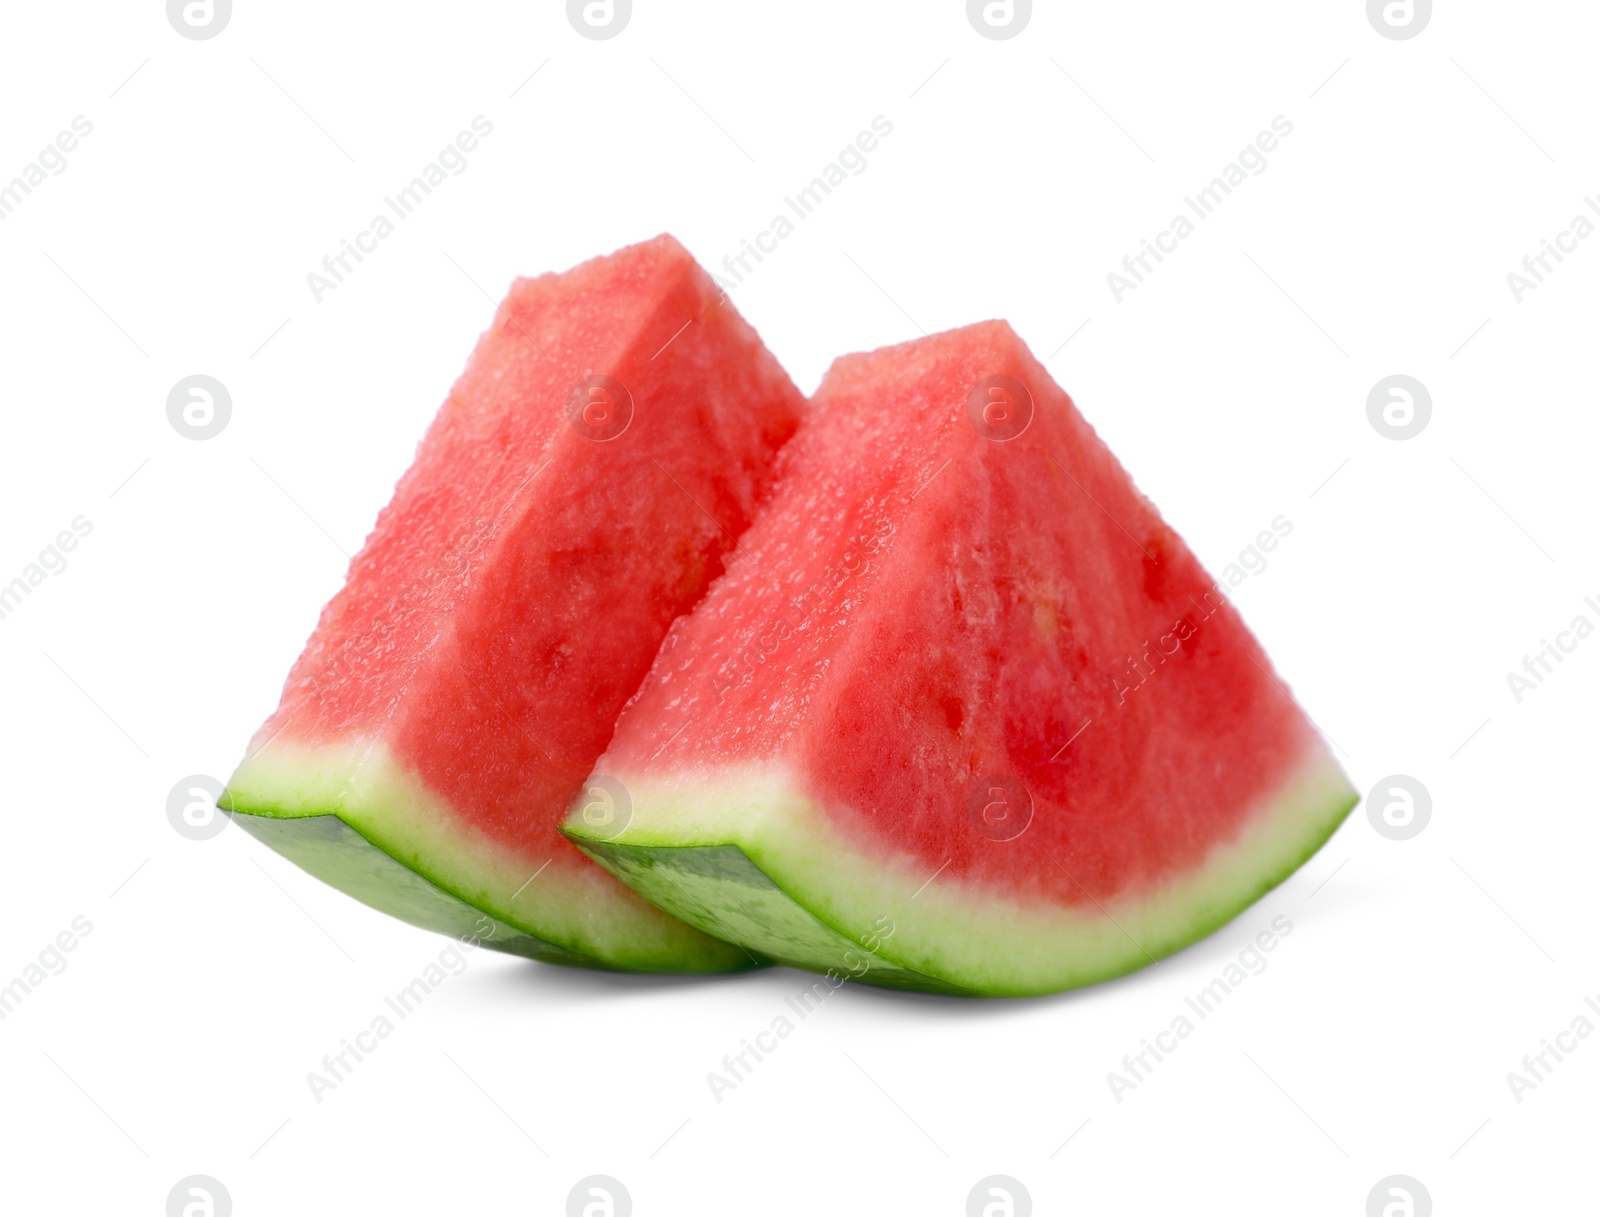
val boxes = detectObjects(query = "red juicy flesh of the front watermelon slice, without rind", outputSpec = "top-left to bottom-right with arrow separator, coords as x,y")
603,323 -> 1320,905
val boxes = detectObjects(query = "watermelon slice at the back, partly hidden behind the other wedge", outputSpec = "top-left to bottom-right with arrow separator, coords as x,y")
221,237 -> 803,971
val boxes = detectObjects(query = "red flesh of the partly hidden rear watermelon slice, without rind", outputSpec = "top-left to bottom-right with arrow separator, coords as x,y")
256,237 -> 803,868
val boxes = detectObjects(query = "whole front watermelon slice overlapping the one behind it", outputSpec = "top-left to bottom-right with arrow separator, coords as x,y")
566,321 -> 1355,995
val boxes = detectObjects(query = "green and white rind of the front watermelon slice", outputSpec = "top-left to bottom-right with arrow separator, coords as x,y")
563,744 -> 1358,996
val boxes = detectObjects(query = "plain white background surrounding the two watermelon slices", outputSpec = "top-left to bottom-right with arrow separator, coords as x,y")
0,0 -> 1600,1217
